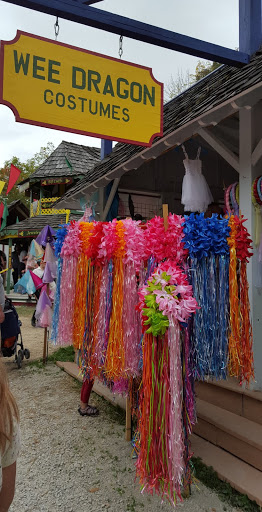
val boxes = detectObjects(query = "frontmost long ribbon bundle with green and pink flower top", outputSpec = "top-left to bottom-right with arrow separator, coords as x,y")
137,260 -> 197,504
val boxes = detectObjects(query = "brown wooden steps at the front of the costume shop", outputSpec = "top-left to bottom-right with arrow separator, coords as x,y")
192,379 -> 262,506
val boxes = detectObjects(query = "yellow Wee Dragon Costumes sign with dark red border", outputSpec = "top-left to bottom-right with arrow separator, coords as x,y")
0,31 -> 163,146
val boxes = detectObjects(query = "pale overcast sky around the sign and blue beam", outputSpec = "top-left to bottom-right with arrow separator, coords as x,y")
0,0 -> 238,165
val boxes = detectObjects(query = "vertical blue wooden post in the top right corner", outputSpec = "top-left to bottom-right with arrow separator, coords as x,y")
239,0 -> 262,55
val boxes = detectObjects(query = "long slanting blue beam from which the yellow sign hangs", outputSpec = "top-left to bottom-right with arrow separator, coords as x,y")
2,0 -> 249,66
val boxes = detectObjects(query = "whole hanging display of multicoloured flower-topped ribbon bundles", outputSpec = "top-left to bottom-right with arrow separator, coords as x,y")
52,214 -> 254,504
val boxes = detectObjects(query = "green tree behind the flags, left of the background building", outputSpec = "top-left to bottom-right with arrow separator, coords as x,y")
0,142 -> 55,206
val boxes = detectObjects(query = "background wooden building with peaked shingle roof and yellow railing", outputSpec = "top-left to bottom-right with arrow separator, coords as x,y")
0,141 -> 100,293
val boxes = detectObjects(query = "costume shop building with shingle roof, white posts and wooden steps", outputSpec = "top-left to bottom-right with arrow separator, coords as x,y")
57,46 -> 262,505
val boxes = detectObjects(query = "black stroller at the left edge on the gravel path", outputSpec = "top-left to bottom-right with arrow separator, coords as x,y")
1,298 -> 30,368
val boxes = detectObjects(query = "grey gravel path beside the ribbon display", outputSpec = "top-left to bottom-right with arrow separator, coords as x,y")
3,312 -> 243,512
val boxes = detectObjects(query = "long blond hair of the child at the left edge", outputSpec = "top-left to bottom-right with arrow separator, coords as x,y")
0,358 -> 19,453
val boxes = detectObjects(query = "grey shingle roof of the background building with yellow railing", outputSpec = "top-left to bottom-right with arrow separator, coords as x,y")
29,141 -> 100,181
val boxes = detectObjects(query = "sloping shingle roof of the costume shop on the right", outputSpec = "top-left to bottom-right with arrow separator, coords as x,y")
59,46 -> 262,202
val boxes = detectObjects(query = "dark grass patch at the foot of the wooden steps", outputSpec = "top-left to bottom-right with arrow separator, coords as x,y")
192,457 -> 261,512
